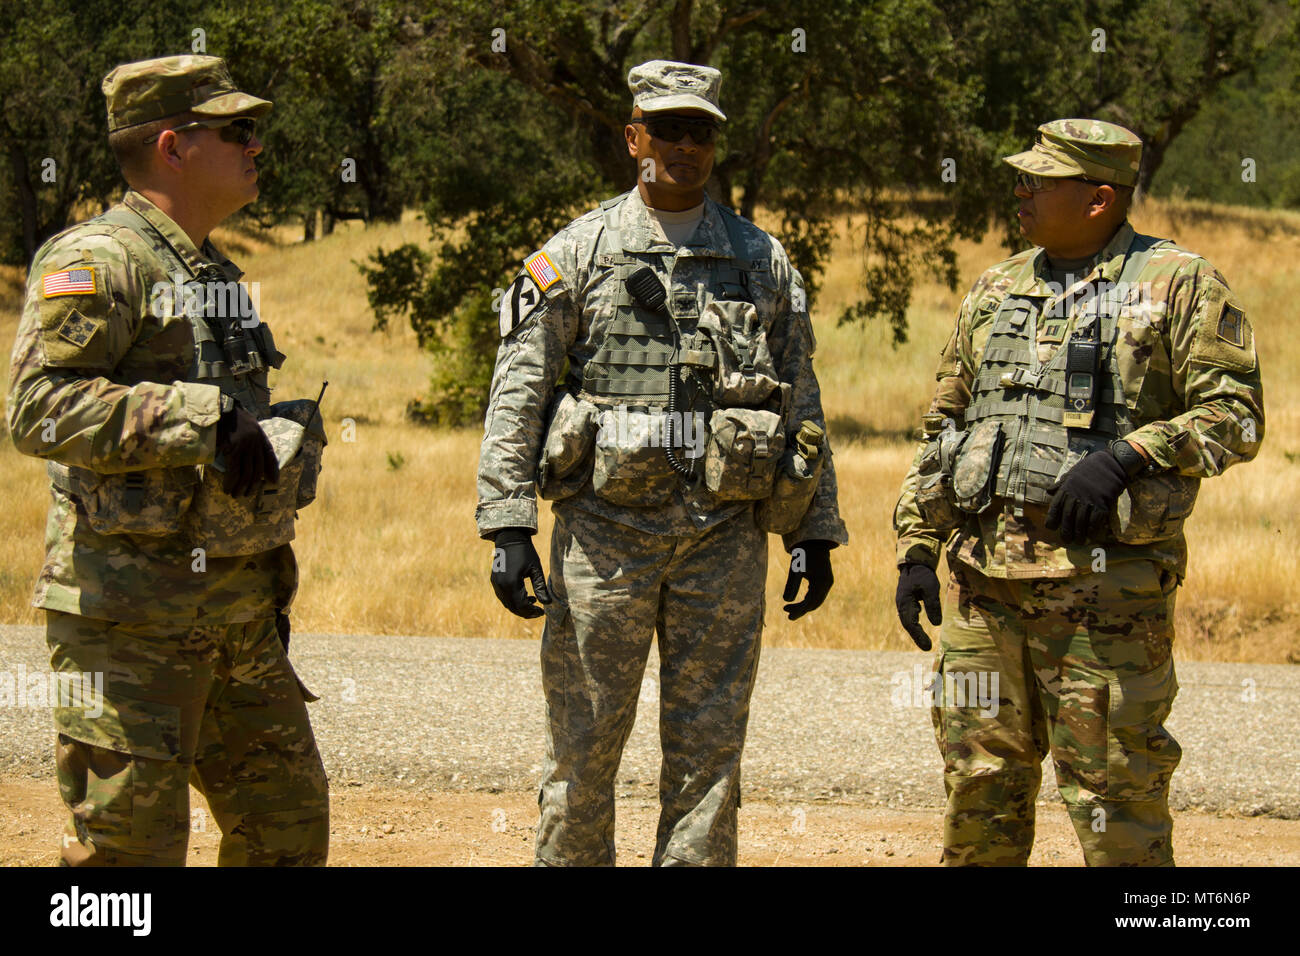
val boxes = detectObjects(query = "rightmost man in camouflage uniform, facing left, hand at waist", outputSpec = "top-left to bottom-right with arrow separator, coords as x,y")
894,120 -> 1264,865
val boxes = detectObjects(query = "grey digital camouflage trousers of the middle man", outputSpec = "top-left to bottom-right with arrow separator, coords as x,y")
537,506 -> 767,866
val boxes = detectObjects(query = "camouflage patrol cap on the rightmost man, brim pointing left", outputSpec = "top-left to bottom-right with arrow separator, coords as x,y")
1002,120 -> 1141,186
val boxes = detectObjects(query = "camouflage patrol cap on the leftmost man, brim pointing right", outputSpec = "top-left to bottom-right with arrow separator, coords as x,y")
104,55 -> 270,133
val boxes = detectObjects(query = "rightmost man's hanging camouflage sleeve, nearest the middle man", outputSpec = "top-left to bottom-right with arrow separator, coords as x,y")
893,293 -> 975,568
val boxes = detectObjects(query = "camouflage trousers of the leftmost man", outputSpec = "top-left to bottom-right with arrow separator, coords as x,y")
46,611 -> 329,866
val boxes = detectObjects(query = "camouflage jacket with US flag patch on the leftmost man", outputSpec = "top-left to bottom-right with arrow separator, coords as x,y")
8,191 -> 296,624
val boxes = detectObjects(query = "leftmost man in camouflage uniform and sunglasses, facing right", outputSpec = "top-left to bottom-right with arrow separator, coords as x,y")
8,56 -> 329,865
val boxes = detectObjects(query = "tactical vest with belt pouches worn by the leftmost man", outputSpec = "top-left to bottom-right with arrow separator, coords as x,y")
48,204 -> 325,558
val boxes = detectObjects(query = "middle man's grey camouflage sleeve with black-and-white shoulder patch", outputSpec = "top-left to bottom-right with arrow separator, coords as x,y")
475,241 -> 579,537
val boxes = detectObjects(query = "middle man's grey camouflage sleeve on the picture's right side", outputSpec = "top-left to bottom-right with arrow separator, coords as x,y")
768,256 -> 849,551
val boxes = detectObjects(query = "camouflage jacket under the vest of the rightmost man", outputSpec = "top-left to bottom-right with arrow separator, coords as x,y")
894,222 -> 1264,578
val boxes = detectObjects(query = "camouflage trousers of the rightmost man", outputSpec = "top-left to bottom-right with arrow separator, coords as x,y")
932,561 -> 1182,866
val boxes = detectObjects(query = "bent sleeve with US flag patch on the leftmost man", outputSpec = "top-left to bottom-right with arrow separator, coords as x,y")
7,235 -> 220,473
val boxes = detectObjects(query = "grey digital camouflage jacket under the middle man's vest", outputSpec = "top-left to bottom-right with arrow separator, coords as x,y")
476,190 -> 849,549
